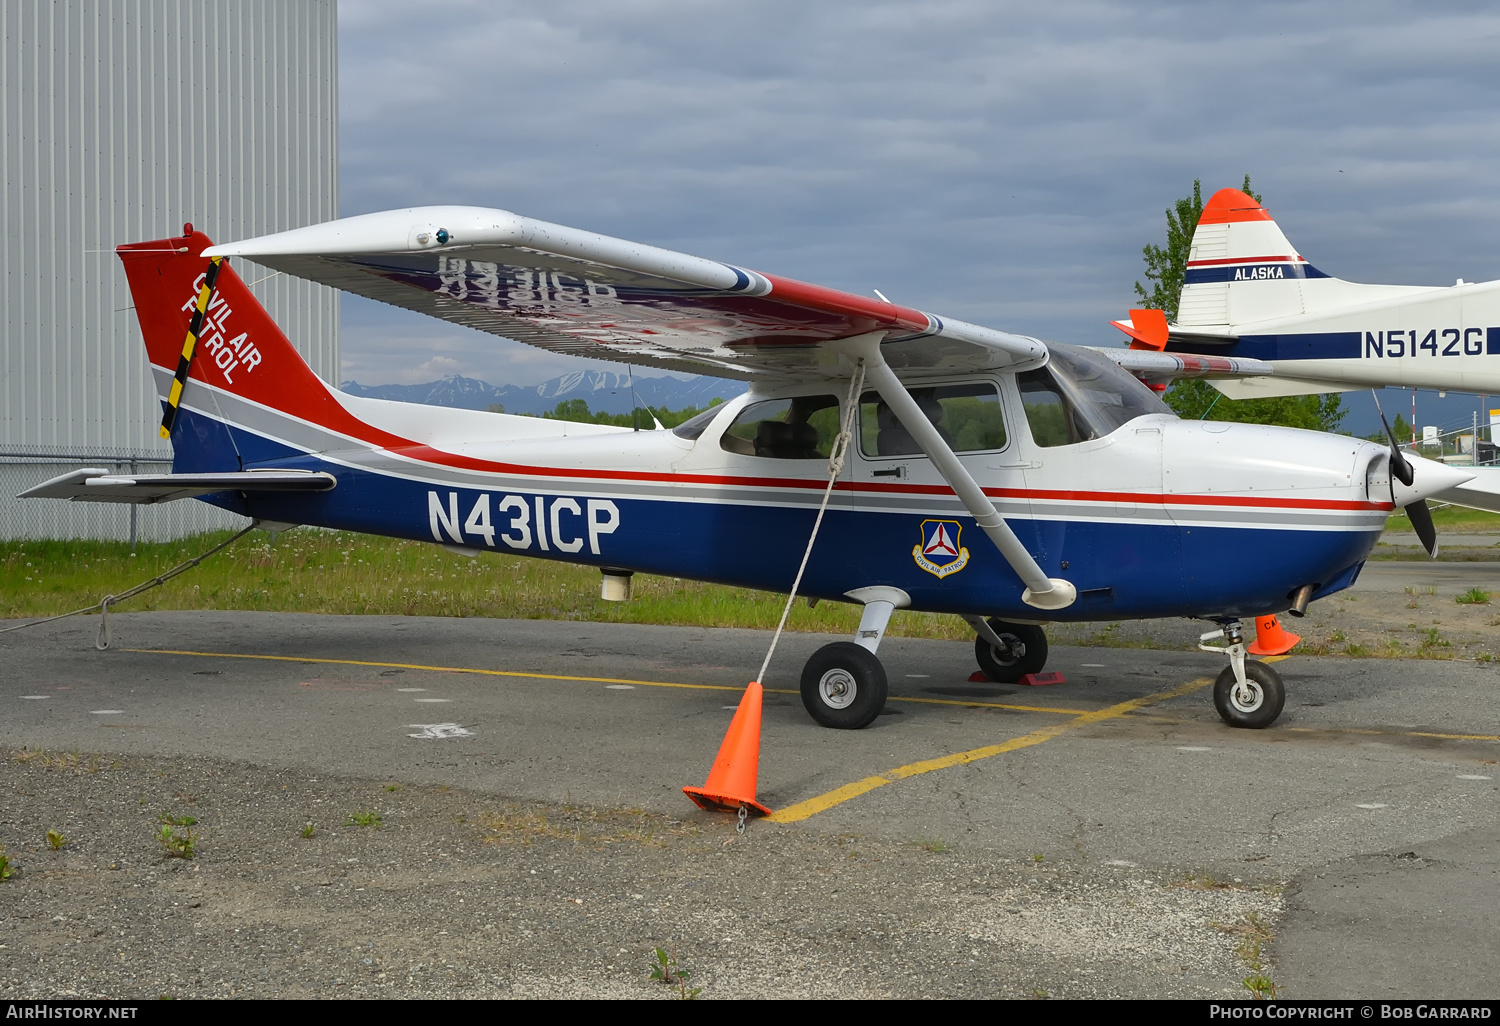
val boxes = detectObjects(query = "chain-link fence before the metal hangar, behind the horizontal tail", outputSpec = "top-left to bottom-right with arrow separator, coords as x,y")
0,446 -> 249,545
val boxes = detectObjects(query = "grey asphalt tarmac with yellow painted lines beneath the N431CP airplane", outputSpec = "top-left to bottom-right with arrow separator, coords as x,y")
0,606 -> 1500,998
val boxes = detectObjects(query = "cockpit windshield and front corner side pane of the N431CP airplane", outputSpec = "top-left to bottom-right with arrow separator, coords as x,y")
1016,344 -> 1176,447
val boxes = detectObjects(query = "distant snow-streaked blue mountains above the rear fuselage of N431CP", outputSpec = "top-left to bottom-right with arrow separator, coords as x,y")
339,371 -> 746,414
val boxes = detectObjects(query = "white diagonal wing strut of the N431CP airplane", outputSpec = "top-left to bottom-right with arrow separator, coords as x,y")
830,332 -> 1079,609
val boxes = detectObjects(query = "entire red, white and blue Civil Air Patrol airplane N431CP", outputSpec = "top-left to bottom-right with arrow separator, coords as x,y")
20,207 -> 1469,728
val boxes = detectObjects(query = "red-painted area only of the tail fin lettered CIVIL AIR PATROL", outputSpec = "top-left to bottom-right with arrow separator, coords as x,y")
116,225 -> 342,420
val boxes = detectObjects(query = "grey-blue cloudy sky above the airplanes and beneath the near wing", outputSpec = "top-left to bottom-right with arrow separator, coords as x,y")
339,0 -> 1500,402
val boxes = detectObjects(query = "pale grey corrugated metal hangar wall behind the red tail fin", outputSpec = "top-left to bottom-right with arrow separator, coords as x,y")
0,0 -> 339,540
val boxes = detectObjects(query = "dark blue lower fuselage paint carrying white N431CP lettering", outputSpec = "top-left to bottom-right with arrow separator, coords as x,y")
174,410 -> 1379,621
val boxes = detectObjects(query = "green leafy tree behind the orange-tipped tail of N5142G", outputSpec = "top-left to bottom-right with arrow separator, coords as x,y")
1136,174 -> 1347,431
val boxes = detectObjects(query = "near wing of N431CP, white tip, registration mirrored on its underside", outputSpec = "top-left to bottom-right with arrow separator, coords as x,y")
204,207 -> 1047,380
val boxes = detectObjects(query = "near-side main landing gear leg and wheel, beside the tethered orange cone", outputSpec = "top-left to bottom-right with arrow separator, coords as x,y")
803,588 -> 912,731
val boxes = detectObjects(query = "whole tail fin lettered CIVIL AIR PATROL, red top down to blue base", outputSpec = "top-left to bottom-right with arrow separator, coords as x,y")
116,225 -> 342,473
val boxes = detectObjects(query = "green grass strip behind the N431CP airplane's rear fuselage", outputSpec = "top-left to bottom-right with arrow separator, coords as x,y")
0,528 -> 974,641
